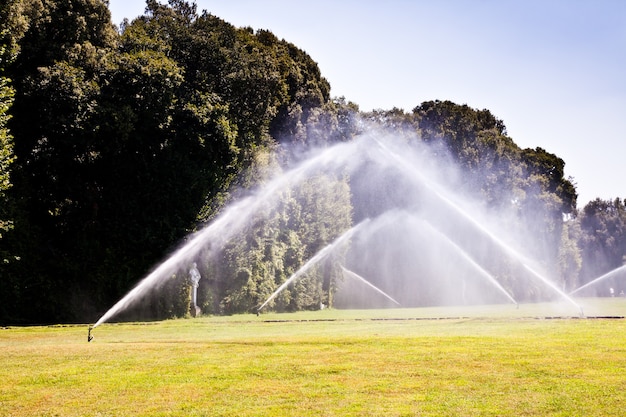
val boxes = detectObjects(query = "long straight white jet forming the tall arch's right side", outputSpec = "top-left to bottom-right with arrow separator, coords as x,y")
374,138 -> 584,316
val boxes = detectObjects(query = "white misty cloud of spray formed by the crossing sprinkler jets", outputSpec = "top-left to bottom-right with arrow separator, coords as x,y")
96,120 -> 582,326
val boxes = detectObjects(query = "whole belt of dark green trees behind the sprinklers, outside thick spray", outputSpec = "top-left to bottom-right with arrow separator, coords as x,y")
0,0 -> 626,323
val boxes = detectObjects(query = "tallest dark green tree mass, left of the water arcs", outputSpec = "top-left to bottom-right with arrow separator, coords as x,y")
3,0 -> 342,321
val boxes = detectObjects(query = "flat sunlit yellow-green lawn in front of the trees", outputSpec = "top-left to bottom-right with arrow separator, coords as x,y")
0,299 -> 626,416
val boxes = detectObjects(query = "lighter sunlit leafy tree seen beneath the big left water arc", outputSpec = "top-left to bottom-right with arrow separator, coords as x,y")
204,174 -> 352,314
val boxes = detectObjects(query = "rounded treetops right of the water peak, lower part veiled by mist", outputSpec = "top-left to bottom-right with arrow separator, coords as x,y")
413,101 -> 576,298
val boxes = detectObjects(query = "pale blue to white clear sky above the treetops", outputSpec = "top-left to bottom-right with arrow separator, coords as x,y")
109,0 -> 626,208
